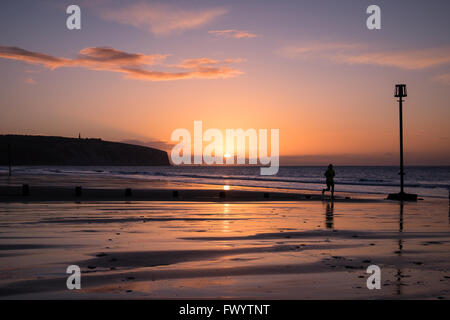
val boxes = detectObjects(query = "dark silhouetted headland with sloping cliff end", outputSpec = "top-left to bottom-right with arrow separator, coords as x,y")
0,135 -> 170,166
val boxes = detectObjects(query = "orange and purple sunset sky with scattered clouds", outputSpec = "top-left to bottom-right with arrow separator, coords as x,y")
0,0 -> 450,165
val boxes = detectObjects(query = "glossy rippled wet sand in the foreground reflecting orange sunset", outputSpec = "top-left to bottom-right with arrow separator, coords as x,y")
0,198 -> 450,299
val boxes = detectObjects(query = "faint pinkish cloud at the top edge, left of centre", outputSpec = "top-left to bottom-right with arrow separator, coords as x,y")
100,2 -> 227,35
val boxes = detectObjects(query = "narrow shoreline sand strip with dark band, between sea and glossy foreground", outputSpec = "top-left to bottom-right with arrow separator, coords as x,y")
0,173 -> 386,202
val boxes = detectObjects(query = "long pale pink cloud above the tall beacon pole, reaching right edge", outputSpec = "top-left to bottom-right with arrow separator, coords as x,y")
278,43 -> 450,70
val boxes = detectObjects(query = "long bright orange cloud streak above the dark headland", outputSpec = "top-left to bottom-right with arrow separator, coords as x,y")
0,46 -> 242,81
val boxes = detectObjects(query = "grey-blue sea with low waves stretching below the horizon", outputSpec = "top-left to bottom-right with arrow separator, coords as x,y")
0,166 -> 450,198
